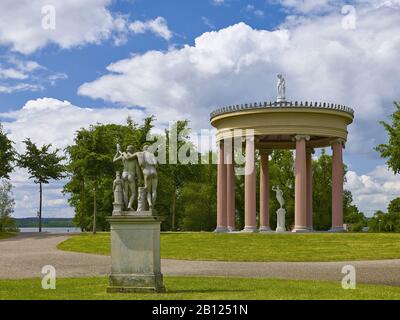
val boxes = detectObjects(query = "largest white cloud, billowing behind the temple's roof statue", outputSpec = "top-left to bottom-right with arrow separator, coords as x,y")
78,3 -> 400,156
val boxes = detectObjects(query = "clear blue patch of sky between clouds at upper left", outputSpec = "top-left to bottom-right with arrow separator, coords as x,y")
0,0 -> 285,112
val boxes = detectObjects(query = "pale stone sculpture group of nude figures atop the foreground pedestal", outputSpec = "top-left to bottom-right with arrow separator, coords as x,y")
113,144 -> 158,215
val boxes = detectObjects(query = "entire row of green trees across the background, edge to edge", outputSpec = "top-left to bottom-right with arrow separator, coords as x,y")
5,104 -> 400,231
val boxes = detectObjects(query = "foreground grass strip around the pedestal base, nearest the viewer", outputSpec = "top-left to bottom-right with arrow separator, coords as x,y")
0,277 -> 400,300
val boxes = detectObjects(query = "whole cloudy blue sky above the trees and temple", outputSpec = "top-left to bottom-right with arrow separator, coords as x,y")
0,0 -> 400,216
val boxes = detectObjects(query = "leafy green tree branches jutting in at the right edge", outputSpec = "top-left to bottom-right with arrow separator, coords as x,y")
375,102 -> 400,174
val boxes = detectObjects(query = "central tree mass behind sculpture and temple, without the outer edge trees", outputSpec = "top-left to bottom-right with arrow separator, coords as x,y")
64,118 -> 366,231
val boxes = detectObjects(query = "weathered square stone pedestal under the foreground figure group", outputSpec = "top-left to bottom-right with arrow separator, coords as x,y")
107,211 -> 165,292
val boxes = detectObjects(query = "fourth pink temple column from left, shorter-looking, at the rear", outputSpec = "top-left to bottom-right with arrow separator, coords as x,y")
260,150 -> 271,231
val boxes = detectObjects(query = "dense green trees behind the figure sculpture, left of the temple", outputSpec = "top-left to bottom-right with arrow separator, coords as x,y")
64,117 -> 212,230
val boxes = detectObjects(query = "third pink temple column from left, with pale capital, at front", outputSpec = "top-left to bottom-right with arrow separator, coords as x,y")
243,137 -> 257,232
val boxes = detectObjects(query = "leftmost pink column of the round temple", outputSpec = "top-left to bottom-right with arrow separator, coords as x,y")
215,141 -> 227,232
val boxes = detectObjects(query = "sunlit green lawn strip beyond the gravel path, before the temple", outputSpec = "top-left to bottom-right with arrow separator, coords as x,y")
58,232 -> 400,261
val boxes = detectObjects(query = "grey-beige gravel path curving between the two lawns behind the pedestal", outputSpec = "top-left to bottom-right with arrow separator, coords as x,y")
0,233 -> 400,286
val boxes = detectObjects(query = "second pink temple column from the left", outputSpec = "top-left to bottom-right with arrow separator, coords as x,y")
225,139 -> 236,231
